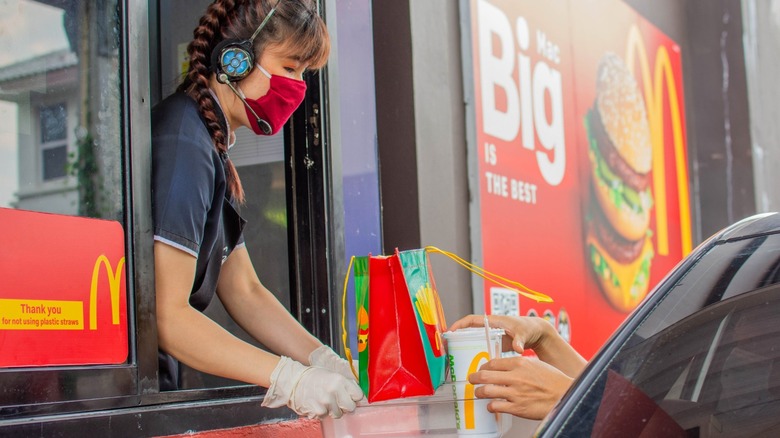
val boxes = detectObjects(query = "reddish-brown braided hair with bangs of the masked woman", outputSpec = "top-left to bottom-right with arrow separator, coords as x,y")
177,0 -> 330,203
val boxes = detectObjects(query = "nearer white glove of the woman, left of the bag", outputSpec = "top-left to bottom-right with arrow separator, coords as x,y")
262,356 -> 363,418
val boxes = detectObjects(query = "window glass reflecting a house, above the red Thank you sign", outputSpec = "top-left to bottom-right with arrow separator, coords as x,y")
0,0 -> 123,220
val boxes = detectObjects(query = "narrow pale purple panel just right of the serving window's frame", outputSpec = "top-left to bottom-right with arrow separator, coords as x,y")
329,0 -> 382,351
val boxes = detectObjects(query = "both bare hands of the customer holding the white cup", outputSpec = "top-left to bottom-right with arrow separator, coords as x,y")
449,315 -> 587,420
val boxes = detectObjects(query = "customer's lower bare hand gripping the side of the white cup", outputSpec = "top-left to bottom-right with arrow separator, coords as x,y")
469,356 -> 573,420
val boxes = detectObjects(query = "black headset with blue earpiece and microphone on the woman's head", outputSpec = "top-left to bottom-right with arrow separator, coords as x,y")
211,0 -> 281,135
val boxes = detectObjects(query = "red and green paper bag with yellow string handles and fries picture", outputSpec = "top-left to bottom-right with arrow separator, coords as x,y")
342,246 -> 552,403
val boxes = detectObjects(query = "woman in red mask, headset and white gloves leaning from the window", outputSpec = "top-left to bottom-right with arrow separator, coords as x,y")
152,0 -> 363,418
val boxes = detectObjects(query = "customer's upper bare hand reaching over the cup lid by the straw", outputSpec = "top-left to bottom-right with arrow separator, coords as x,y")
449,315 -> 558,354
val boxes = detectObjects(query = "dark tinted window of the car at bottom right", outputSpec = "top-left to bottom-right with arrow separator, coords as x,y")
561,235 -> 780,437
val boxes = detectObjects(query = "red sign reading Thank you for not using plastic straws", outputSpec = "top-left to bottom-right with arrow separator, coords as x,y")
0,208 -> 128,367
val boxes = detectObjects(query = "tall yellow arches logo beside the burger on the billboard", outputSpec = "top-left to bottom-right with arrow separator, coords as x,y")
626,25 -> 692,257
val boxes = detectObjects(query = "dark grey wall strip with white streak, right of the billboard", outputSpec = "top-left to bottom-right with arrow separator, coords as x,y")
684,0 -> 756,241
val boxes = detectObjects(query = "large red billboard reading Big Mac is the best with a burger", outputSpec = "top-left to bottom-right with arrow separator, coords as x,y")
466,0 -> 692,357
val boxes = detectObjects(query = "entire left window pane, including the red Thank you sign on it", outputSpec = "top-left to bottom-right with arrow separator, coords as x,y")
0,0 -> 126,372
